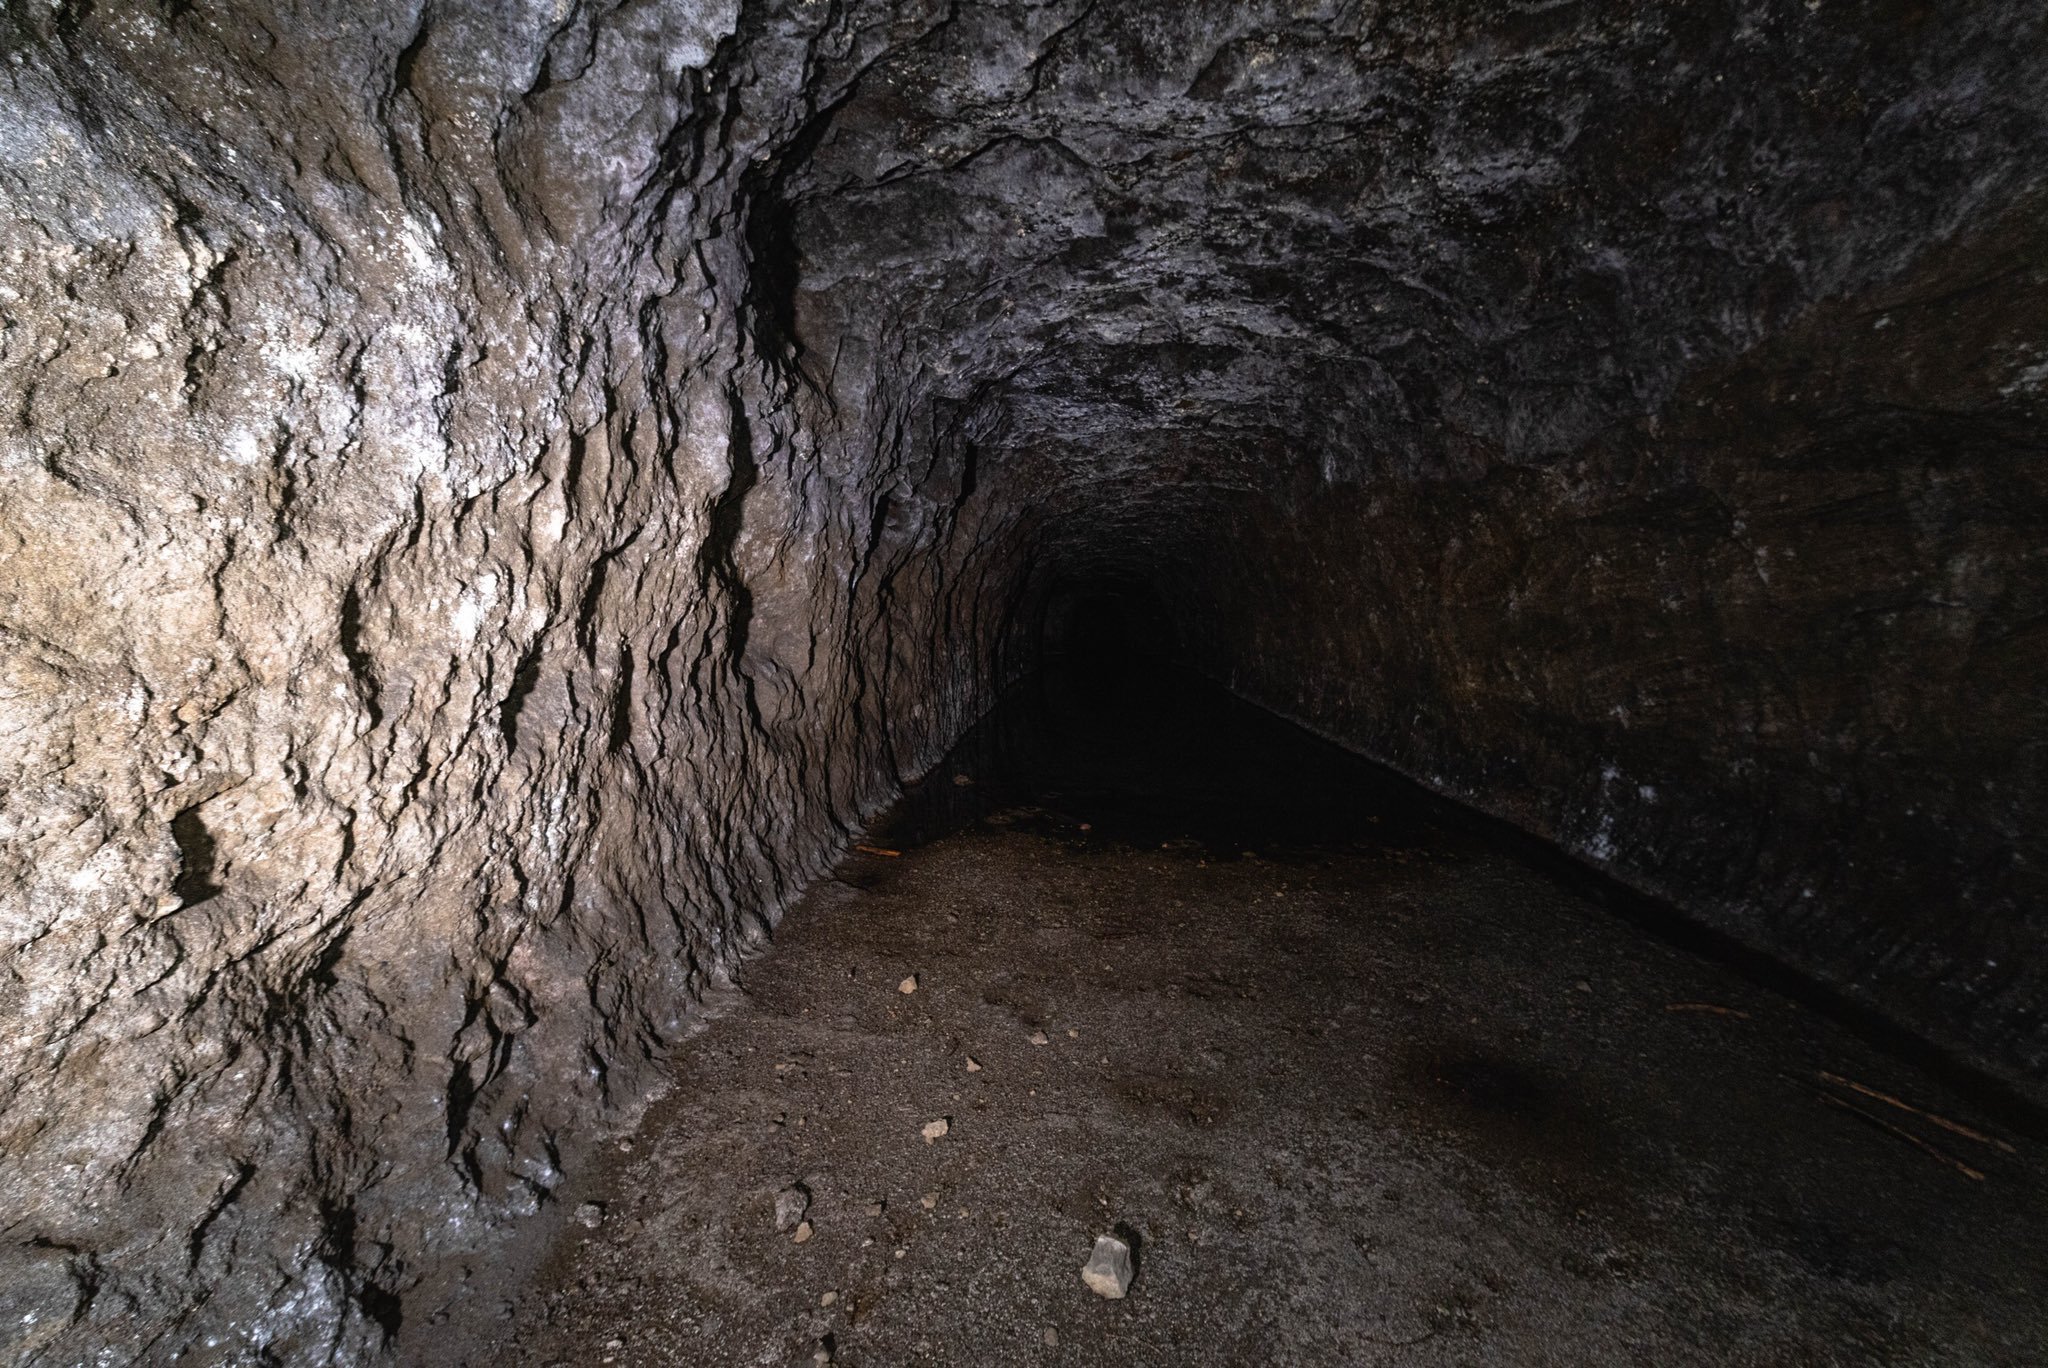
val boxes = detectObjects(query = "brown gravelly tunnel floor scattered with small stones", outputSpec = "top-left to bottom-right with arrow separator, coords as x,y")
452,682 -> 2048,1366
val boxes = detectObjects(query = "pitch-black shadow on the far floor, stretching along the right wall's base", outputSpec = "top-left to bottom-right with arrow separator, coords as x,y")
872,610 -> 2048,1139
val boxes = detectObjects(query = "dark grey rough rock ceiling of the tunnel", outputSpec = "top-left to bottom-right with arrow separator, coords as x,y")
774,2 -> 2038,508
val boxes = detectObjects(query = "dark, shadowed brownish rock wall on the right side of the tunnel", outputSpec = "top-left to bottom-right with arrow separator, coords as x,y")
1182,205 -> 2048,1096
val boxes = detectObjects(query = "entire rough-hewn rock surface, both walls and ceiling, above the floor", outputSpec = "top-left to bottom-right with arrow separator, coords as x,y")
0,0 -> 2048,1364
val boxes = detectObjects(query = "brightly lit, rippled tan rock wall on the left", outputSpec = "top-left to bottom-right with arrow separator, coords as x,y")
0,0 -> 1001,1364
